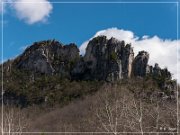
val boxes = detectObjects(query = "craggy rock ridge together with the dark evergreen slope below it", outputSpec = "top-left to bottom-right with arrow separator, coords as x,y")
1,36 -> 177,104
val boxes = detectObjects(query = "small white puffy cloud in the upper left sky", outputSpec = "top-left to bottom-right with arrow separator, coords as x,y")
11,0 -> 53,24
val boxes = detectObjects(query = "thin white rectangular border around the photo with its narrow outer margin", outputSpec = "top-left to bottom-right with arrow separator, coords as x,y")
1,1 -> 180,135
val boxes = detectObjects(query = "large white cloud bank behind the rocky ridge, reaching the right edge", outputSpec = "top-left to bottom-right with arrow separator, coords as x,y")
80,28 -> 180,82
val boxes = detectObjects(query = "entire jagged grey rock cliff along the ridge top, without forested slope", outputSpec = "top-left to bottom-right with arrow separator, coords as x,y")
5,36 -> 174,84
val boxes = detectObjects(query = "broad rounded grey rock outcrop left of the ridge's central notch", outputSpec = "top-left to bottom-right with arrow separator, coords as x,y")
15,40 -> 79,76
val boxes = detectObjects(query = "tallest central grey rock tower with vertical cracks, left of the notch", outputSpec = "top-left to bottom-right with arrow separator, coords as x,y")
81,36 -> 134,81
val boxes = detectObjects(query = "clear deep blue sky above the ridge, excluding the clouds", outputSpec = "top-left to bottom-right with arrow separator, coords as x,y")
0,0 -> 177,59
